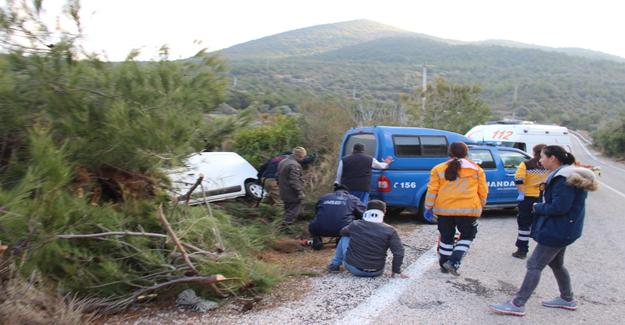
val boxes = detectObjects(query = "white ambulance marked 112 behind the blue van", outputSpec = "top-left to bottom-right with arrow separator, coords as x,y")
466,120 -> 572,155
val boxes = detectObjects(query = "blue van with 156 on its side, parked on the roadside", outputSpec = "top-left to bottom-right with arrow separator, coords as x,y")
340,126 -> 530,216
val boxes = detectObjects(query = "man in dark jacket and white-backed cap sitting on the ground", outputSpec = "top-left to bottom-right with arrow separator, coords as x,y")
328,200 -> 408,278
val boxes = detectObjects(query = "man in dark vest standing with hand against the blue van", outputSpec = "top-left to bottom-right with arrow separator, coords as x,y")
336,143 -> 393,204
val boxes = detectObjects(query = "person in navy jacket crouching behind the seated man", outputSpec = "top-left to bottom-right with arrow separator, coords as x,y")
308,184 -> 367,249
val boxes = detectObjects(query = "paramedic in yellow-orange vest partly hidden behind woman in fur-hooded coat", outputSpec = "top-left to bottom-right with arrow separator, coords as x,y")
512,144 -> 549,259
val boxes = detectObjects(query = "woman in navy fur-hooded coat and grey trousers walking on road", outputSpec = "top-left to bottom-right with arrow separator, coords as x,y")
489,146 -> 598,316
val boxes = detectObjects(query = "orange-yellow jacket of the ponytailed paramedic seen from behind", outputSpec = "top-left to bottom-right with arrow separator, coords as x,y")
425,159 -> 488,217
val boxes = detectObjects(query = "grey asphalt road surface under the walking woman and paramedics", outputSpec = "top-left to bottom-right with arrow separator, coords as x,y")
346,138 -> 625,324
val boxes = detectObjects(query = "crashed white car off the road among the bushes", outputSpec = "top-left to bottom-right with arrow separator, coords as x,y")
167,152 -> 263,204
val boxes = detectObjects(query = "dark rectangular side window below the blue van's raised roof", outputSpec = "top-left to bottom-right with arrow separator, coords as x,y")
393,135 -> 447,157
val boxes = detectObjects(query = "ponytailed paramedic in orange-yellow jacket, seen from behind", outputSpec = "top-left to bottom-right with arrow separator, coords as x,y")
423,142 -> 488,276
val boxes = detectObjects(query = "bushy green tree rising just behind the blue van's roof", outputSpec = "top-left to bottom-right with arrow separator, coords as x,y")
404,78 -> 491,133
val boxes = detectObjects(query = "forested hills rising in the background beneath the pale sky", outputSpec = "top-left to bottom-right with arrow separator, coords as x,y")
221,20 -> 625,128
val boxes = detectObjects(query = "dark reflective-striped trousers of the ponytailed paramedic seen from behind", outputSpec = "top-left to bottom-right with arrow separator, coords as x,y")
438,215 -> 477,267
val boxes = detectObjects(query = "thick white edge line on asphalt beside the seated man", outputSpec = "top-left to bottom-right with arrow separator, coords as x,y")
336,246 -> 438,325
